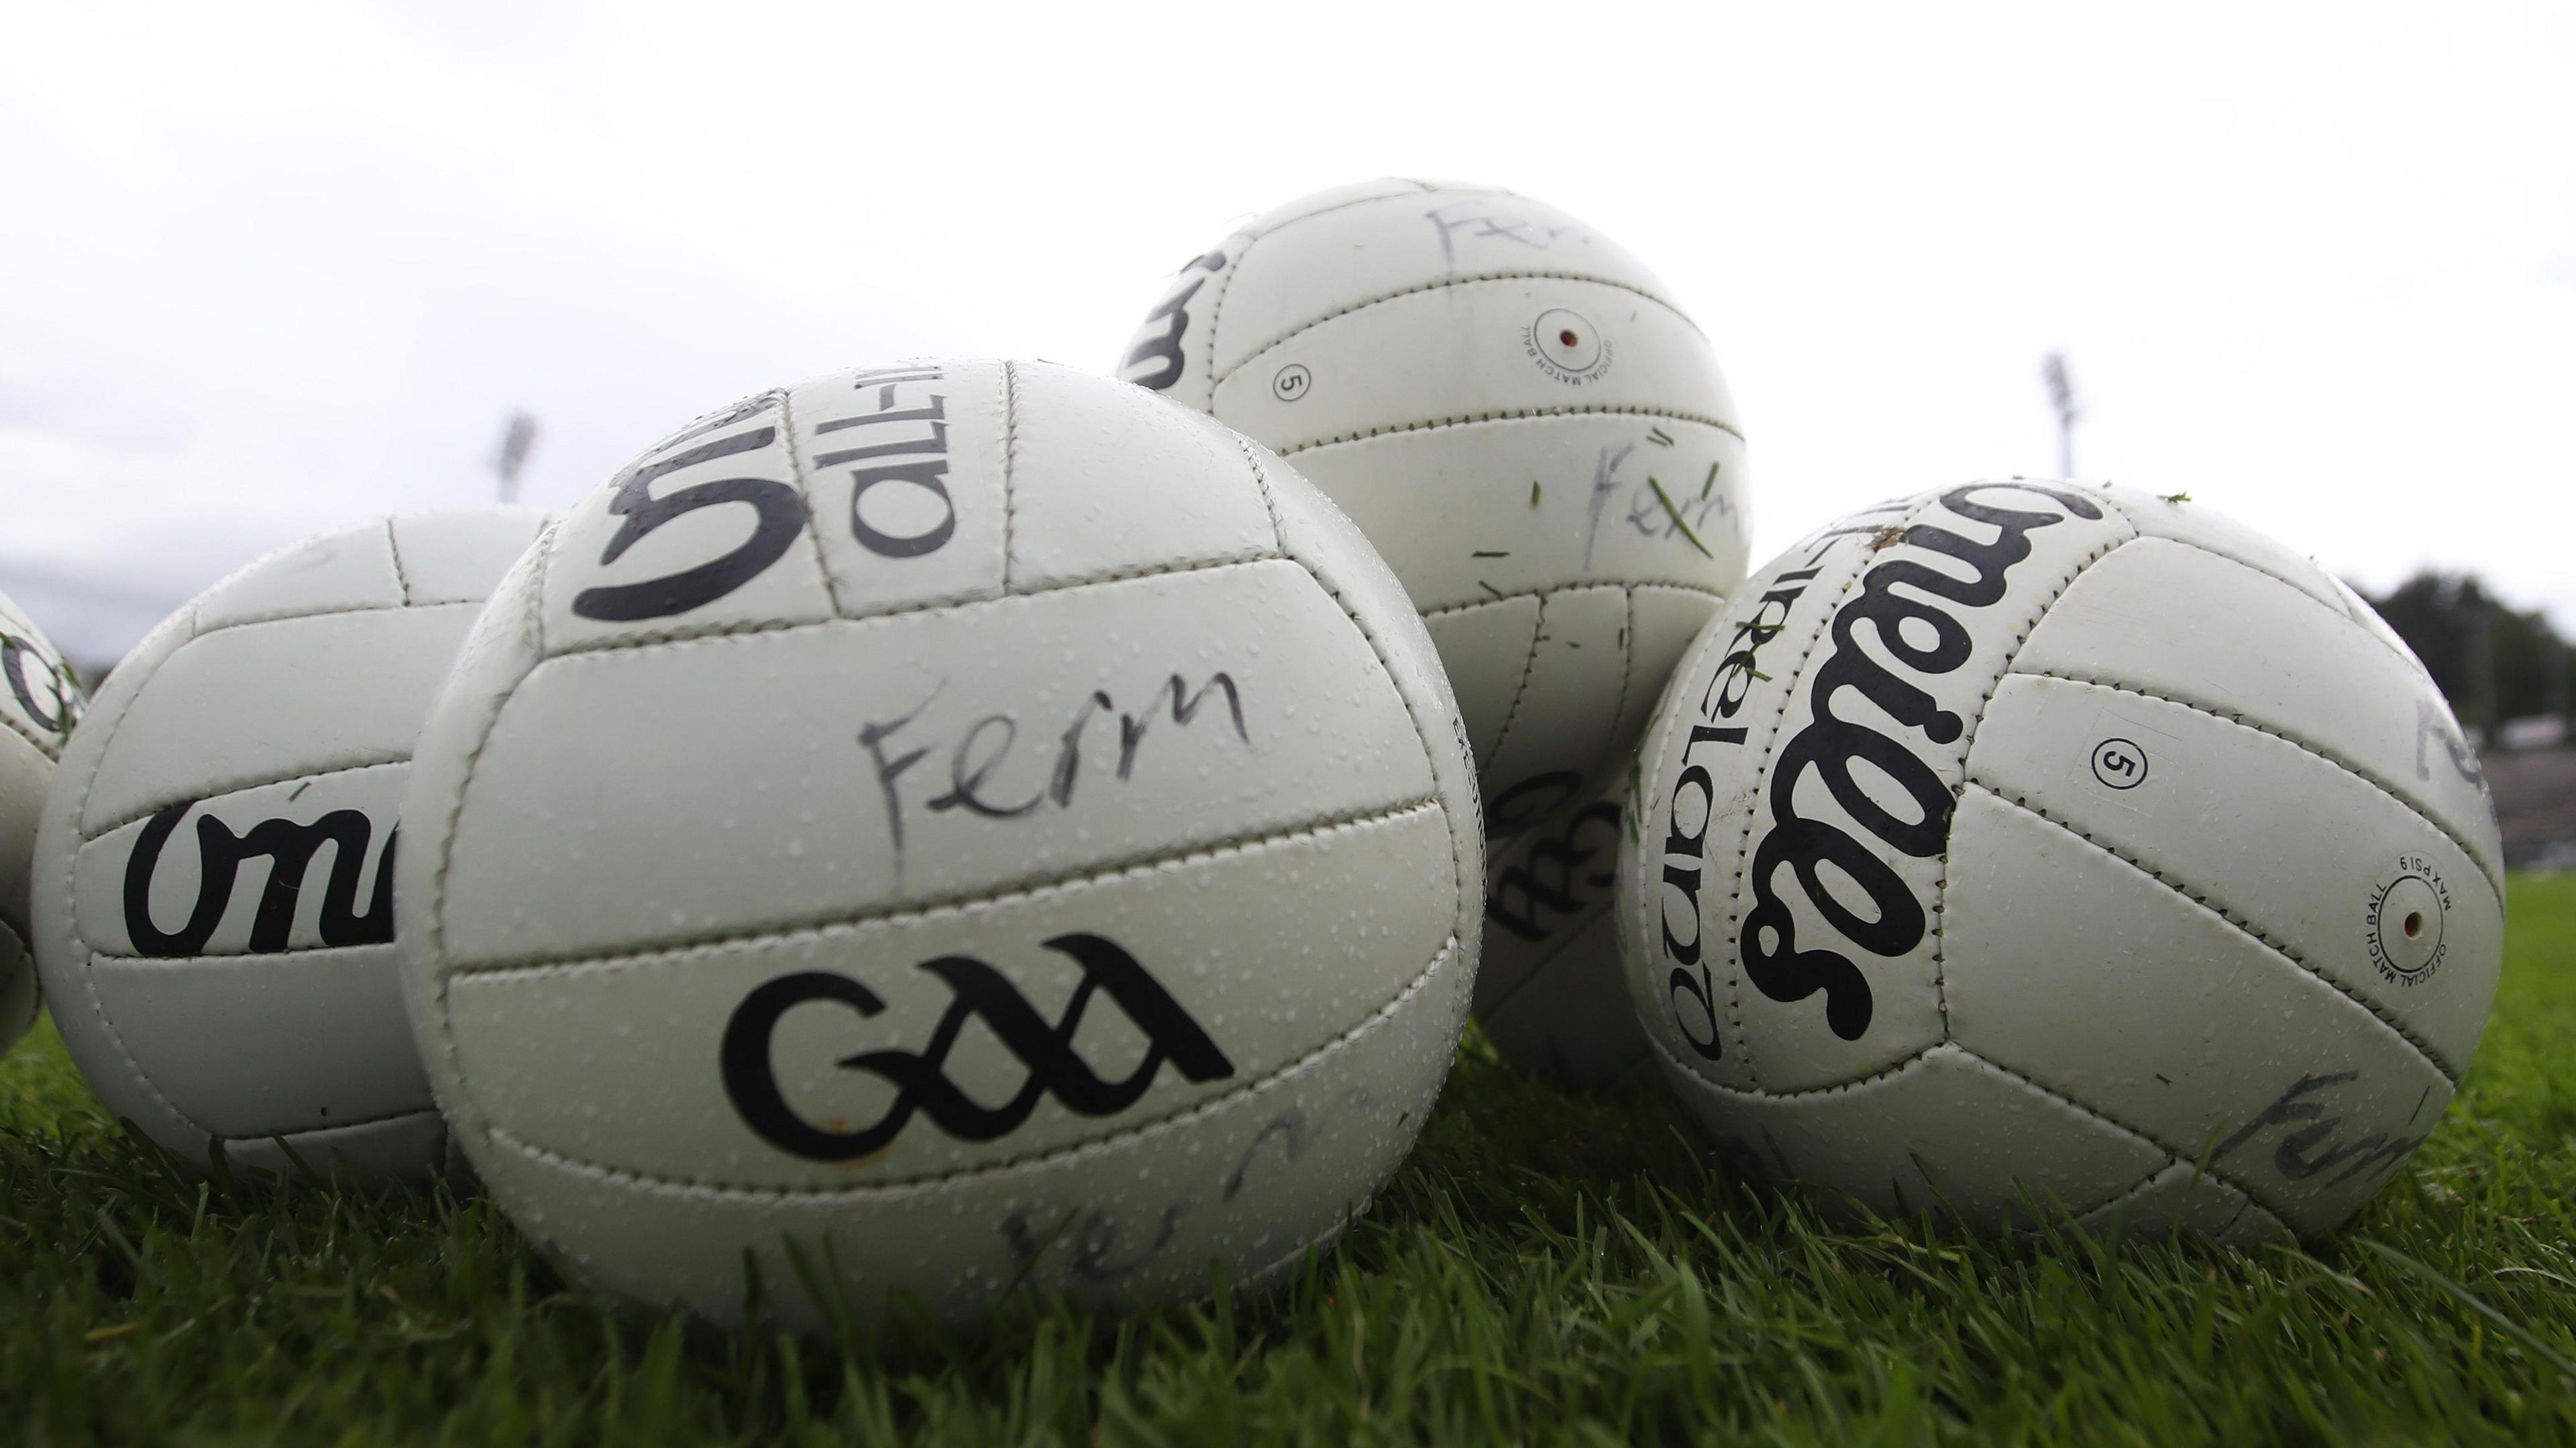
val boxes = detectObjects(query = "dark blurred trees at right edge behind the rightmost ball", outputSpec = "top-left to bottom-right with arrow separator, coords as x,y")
2362,569 -> 2576,740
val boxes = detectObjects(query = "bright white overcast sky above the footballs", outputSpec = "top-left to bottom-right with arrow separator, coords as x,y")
0,0 -> 2576,659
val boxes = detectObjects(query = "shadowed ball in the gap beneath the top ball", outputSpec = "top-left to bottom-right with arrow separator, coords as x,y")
1476,781 -> 1646,1087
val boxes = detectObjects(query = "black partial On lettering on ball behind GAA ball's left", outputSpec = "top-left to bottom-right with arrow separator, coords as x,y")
123,801 -> 402,958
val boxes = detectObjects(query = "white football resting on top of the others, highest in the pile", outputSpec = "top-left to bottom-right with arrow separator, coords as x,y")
1120,180 -> 1749,838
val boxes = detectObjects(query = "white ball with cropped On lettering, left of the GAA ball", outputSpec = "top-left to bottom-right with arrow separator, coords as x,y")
34,508 -> 543,1180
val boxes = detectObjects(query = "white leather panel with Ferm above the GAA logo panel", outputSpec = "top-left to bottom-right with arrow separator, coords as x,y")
441,559 -> 1432,964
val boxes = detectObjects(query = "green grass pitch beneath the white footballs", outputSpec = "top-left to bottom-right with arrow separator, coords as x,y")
0,876 -> 2576,1445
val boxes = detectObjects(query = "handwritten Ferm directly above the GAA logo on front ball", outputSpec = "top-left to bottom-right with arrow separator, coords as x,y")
858,670 -> 1252,860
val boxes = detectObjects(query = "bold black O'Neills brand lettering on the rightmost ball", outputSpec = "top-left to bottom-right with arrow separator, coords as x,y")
1736,482 -> 2102,1041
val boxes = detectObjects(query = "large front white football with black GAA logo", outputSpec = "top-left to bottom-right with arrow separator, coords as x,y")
396,361 -> 1484,1327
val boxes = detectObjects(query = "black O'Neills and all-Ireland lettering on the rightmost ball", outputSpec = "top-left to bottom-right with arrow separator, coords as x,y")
1664,482 -> 2102,1059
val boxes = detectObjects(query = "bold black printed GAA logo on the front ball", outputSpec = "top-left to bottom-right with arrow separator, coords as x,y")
718,933 -> 1234,1162
